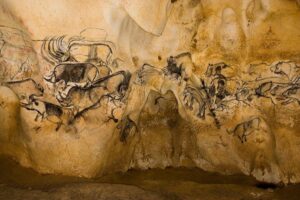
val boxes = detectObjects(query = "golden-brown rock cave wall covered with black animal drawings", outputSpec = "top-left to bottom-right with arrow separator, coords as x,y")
0,0 -> 300,183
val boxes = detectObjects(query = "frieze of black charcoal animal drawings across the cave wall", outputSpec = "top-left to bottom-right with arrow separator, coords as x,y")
0,25 -> 300,147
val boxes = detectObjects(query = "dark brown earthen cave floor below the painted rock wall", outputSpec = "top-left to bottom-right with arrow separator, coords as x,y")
0,156 -> 300,200
